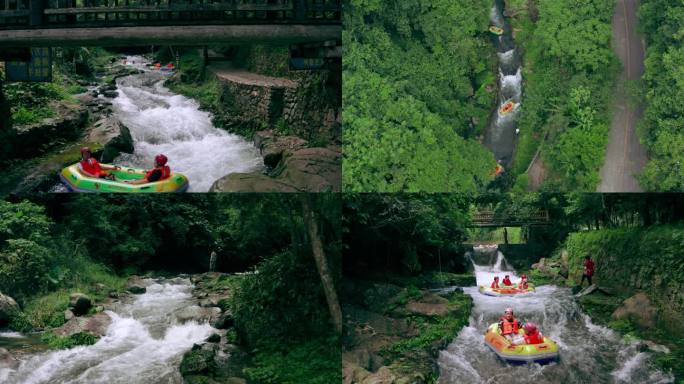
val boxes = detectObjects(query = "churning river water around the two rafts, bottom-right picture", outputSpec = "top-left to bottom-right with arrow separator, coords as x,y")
439,250 -> 674,384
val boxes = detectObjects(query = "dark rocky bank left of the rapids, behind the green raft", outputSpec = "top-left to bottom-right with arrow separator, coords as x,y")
0,63 -> 139,194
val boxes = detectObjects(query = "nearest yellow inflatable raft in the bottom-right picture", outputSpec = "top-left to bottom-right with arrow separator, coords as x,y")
485,323 -> 558,364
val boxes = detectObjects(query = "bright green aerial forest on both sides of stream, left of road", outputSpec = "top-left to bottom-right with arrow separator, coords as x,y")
343,0 -> 619,192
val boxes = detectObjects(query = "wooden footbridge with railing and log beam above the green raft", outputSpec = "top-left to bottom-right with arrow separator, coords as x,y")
0,0 -> 342,47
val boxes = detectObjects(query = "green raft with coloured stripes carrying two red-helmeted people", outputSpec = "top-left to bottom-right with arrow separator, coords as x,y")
59,163 -> 190,193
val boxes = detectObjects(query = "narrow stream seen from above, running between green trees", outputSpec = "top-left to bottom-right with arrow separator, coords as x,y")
484,0 -> 522,166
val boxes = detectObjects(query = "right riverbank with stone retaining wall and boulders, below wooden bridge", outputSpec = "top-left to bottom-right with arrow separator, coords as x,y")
169,63 -> 342,192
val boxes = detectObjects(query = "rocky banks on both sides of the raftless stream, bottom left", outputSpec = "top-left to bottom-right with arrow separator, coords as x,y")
0,273 -> 250,384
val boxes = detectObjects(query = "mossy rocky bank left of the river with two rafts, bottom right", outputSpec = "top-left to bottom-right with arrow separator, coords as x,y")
342,274 -> 474,384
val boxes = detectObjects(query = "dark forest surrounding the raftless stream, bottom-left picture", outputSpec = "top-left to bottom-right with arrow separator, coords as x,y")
0,194 -> 341,384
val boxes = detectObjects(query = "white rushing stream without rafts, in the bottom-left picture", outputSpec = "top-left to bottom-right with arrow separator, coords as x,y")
0,278 -> 214,384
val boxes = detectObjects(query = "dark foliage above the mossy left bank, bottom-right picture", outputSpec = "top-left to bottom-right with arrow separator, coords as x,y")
343,194 -> 470,275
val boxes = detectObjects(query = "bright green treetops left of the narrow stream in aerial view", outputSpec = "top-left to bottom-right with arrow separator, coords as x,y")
343,0 -> 495,192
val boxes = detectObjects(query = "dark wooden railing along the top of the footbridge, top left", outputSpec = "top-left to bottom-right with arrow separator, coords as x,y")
0,0 -> 342,29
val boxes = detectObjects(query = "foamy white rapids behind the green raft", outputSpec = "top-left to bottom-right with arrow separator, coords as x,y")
113,57 -> 263,192
